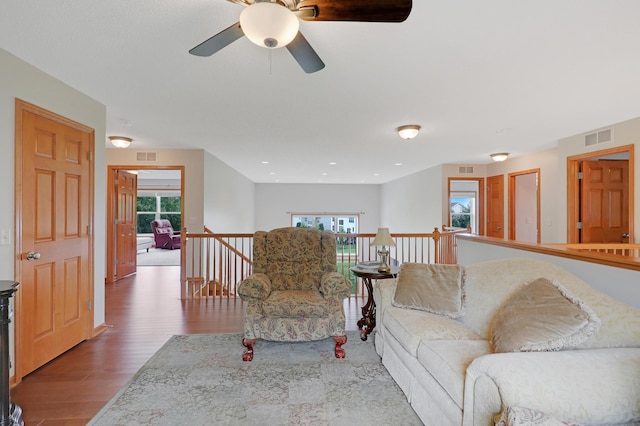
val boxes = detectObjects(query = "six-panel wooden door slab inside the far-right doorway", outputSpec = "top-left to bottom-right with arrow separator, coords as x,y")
580,160 -> 629,243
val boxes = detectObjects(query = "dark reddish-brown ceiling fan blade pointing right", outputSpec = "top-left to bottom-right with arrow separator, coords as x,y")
298,0 -> 412,22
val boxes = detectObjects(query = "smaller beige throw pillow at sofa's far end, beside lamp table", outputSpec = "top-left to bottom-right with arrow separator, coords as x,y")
392,263 -> 465,318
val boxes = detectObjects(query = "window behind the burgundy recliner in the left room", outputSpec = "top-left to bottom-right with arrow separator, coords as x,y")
137,190 -> 182,234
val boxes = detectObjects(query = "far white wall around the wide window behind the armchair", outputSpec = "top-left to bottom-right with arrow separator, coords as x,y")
255,183 -> 380,233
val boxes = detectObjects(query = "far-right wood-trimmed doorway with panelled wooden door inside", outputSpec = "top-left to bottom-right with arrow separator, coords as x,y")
567,145 -> 635,243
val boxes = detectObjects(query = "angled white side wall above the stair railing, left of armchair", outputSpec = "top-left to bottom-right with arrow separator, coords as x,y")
203,152 -> 255,233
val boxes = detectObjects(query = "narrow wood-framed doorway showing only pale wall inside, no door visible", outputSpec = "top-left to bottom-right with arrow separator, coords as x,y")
509,169 -> 540,243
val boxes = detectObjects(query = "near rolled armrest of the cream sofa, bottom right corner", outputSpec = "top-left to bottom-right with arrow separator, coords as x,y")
463,348 -> 640,426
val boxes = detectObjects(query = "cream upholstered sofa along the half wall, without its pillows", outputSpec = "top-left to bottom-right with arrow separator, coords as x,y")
373,259 -> 640,426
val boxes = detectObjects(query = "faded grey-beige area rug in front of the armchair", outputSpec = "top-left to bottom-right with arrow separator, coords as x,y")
89,331 -> 422,426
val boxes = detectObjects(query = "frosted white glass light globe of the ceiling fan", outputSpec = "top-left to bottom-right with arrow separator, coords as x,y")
240,3 -> 300,49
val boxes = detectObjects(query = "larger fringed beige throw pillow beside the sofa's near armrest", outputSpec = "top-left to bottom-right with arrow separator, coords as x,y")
490,278 -> 600,352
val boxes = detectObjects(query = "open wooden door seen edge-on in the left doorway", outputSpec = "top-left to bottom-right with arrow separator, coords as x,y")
115,170 -> 138,279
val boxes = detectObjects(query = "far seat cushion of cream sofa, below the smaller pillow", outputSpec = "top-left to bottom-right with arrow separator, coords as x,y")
384,306 -> 482,357
